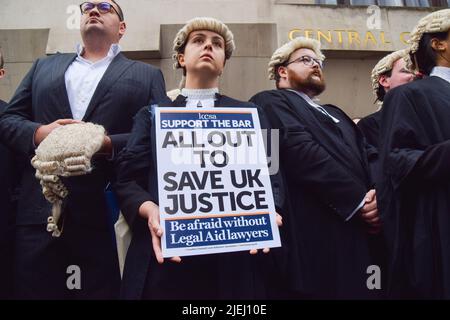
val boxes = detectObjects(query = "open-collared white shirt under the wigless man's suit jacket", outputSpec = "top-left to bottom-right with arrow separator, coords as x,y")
64,44 -> 120,120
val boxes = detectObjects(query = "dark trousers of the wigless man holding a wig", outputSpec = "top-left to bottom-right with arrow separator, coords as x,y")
14,219 -> 120,300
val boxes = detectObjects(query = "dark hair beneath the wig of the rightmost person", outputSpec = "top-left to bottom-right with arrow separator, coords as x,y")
411,31 -> 448,75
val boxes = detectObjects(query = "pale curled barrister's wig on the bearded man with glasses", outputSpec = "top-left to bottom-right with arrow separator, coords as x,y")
268,37 -> 325,80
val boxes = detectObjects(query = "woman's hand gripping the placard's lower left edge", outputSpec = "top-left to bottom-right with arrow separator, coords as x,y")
139,201 -> 181,264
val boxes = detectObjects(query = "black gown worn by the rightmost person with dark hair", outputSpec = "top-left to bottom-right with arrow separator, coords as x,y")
378,77 -> 450,299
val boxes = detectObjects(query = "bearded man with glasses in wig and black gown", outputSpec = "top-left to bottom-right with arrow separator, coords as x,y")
251,37 -> 380,299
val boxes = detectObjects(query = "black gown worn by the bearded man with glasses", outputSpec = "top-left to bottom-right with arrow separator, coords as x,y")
250,90 -> 378,299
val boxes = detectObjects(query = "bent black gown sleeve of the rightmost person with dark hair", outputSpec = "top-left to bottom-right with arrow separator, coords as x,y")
381,86 -> 450,189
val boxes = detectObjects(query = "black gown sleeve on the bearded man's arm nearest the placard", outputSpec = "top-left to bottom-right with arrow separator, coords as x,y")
251,93 -> 367,220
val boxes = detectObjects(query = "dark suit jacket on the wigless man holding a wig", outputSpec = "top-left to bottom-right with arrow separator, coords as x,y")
0,54 -> 165,228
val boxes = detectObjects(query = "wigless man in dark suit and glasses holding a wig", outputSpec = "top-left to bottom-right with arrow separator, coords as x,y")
0,1 -> 165,299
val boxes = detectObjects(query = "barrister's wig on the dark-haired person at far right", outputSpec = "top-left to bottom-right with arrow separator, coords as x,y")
406,9 -> 450,70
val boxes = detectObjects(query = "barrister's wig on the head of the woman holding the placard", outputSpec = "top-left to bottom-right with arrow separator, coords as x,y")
173,17 -> 236,69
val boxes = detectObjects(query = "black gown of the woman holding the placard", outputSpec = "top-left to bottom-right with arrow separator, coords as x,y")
114,95 -> 282,300
